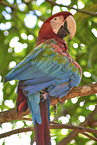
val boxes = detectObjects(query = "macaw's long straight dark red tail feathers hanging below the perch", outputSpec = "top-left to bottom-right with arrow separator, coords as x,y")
34,100 -> 50,145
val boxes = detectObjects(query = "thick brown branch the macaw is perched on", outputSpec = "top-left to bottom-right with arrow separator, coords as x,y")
0,83 -> 97,123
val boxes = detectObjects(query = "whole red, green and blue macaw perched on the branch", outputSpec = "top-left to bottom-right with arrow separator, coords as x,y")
5,11 -> 82,145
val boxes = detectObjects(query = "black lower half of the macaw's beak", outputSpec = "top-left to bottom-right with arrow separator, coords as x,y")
57,21 -> 69,38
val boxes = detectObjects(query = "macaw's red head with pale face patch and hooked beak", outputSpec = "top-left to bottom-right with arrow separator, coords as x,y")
37,12 -> 76,44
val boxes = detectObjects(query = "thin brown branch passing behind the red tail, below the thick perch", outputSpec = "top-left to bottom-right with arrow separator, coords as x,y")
0,122 -> 97,141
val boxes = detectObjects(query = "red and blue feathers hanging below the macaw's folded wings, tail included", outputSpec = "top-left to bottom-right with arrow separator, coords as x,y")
17,86 -> 50,145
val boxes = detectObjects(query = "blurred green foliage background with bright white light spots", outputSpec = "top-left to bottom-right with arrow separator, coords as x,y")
0,0 -> 97,145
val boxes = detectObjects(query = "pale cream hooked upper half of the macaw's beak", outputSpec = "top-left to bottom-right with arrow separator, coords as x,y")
64,15 -> 76,40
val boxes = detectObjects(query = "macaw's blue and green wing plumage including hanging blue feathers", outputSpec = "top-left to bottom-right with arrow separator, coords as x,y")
5,39 -> 81,125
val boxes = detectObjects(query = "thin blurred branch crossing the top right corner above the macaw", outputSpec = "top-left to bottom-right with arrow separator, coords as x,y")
46,0 -> 97,16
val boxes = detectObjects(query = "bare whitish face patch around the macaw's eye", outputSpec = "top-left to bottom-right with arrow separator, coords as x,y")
50,15 -> 64,34
